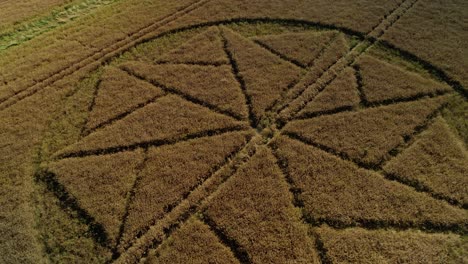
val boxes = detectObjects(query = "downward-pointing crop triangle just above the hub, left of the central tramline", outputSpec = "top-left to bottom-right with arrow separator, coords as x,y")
223,29 -> 301,120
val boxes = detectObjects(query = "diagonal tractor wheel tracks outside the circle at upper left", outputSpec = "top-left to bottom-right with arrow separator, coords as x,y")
0,0 -> 210,111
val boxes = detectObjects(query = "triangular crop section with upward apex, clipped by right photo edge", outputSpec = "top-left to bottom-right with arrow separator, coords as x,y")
384,117 -> 468,205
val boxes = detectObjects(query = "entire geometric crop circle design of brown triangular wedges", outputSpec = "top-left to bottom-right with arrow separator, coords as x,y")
41,25 -> 468,263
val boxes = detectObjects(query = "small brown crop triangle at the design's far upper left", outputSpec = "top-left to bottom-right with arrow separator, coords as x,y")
86,67 -> 164,129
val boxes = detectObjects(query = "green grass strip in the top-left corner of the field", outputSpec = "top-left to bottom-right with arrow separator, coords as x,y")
0,0 -> 120,51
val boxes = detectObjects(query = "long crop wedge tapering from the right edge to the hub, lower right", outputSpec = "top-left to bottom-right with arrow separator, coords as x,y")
274,137 -> 468,230
